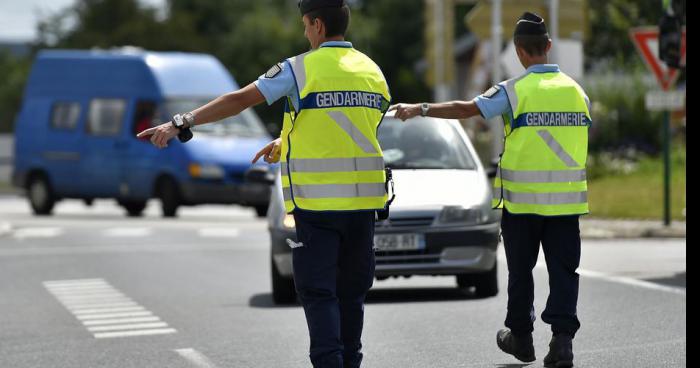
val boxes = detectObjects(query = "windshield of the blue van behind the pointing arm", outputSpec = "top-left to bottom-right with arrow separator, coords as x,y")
163,98 -> 267,137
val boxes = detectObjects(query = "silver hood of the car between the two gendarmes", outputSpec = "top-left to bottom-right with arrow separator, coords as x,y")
391,169 -> 491,211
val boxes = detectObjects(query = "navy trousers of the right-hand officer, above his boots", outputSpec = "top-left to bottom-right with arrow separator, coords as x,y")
501,210 -> 581,337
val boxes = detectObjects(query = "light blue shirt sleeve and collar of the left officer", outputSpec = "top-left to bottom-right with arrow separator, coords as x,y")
255,41 -> 352,111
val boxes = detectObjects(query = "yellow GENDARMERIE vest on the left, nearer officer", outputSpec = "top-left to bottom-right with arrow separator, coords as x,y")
280,46 -> 391,212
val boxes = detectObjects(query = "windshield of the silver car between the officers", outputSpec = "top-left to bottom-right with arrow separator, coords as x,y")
378,117 -> 476,170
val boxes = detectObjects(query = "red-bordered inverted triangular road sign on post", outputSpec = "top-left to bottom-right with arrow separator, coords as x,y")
630,27 -> 685,91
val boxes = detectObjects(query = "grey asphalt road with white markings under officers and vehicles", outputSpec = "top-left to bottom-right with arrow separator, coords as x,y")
0,197 -> 686,368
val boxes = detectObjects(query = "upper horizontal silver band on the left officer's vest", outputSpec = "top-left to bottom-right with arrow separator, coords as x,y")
282,157 -> 384,173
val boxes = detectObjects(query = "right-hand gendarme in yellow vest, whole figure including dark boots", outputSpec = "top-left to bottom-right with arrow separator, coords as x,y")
390,12 -> 591,367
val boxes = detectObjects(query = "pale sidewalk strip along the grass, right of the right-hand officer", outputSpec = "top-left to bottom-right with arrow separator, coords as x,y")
581,217 -> 686,239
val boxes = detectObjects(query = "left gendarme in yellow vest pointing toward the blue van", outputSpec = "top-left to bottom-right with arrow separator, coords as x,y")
139,0 -> 391,368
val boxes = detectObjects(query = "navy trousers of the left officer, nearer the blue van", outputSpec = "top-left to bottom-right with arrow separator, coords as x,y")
292,210 -> 375,368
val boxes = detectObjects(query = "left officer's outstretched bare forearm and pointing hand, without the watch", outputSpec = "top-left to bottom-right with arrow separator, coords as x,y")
137,83 -> 265,148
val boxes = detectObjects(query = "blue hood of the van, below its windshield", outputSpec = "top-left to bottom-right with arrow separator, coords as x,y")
184,133 -> 271,166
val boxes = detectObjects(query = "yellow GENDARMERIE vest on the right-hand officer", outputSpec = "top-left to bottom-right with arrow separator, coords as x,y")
494,72 -> 591,216
